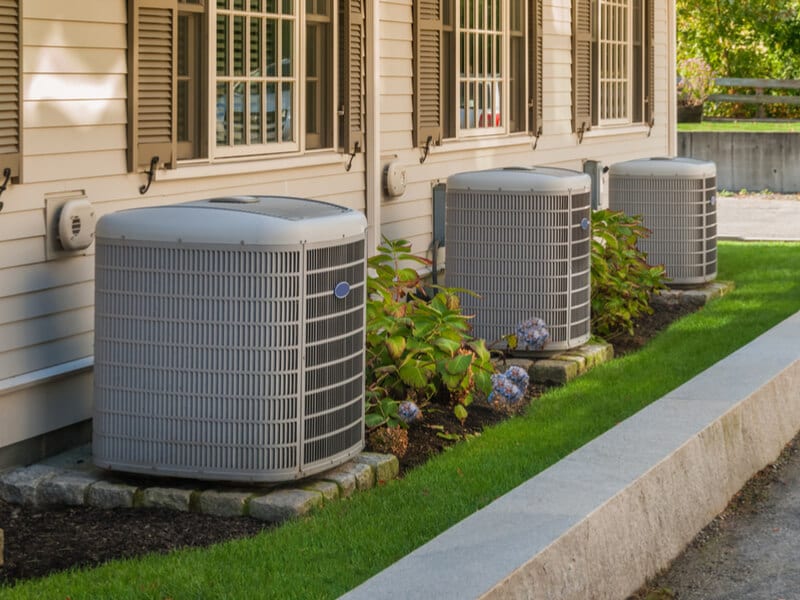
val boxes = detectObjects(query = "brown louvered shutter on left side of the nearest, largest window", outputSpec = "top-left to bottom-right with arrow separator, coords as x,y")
128,0 -> 178,171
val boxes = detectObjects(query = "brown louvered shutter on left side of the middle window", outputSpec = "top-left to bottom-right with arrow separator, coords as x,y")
414,0 -> 442,146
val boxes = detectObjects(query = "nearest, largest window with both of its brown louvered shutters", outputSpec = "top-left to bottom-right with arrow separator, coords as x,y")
128,0 -> 364,168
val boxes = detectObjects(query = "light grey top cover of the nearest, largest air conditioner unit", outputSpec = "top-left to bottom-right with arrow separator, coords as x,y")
97,196 -> 364,246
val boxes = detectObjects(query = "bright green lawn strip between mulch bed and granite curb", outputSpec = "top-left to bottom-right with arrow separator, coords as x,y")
0,242 -> 800,600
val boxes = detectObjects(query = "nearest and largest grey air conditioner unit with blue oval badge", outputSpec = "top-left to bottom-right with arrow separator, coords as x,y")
93,196 -> 366,482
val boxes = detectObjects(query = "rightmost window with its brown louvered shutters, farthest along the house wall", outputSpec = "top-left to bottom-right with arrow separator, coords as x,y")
572,0 -> 654,133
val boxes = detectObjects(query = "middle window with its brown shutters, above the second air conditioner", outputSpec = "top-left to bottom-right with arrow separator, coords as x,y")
414,0 -> 542,146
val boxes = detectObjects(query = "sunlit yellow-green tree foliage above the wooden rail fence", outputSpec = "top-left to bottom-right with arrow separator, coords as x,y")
676,0 -> 800,79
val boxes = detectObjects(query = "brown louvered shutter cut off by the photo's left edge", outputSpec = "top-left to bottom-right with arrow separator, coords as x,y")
0,0 -> 22,182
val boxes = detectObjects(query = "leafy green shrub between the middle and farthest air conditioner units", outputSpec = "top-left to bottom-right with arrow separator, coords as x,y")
591,210 -> 666,339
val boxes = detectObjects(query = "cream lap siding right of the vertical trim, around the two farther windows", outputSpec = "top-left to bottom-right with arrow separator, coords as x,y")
379,0 -> 669,257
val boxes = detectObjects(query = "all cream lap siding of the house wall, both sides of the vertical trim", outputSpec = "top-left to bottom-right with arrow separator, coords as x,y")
0,0 -> 674,467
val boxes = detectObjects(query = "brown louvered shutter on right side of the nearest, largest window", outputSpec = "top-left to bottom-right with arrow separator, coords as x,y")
339,0 -> 366,154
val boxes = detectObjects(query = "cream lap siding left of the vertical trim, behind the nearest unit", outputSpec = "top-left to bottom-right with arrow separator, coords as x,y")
0,0 -> 365,467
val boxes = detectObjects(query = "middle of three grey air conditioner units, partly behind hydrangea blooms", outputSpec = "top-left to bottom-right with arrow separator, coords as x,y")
445,167 -> 591,351
